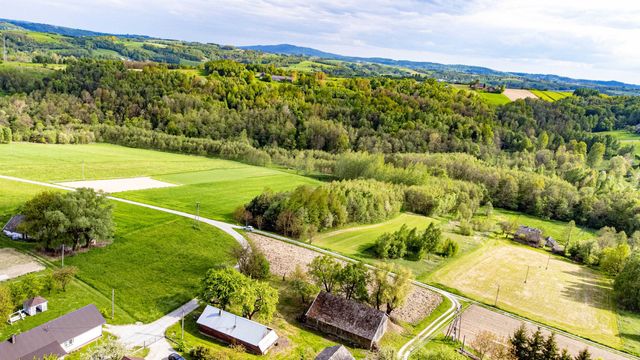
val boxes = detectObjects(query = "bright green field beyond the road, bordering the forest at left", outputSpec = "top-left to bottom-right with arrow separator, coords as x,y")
0,143 -> 319,221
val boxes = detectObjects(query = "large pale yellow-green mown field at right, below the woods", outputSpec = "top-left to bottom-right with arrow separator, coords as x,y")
430,240 -> 622,348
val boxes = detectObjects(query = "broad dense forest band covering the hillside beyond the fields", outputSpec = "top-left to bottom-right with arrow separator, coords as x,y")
0,60 -> 640,233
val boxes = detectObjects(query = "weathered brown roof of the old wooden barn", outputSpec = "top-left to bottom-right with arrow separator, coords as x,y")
306,291 -> 387,341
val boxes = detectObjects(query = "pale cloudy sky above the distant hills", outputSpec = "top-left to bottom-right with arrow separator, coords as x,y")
0,0 -> 640,84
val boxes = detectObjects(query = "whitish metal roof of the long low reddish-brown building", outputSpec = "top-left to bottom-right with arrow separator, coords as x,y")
197,305 -> 278,351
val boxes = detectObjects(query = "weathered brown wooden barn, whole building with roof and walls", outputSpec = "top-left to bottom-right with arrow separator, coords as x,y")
305,291 -> 389,349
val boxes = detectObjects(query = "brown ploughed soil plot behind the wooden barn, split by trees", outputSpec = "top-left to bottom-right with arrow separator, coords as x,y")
247,233 -> 442,324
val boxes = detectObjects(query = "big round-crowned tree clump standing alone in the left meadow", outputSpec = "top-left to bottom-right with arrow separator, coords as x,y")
20,188 -> 114,251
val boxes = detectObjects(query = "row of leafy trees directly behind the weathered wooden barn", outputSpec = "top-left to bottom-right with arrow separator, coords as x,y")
302,255 -> 413,315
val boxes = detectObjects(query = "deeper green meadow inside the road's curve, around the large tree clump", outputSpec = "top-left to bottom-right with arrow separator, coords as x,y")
0,179 -> 237,322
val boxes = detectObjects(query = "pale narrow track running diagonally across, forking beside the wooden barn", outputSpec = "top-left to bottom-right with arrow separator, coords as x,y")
0,175 -> 640,360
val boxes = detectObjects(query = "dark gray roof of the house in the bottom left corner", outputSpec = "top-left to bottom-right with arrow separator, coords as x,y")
0,304 -> 105,360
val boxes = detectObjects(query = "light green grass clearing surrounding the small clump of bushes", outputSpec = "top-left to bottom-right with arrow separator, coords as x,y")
313,213 -> 483,280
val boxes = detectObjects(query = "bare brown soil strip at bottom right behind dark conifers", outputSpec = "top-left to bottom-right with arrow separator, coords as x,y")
460,305 -> 630,360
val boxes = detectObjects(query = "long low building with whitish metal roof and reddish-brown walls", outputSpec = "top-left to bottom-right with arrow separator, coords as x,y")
196,305 -> 278,355
